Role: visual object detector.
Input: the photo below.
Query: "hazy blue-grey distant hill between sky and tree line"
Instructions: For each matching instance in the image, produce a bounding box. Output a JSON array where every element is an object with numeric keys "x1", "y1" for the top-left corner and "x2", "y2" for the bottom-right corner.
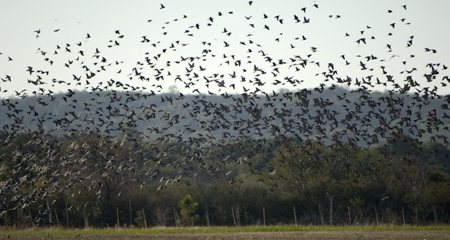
[{"x1": 0, "y1": 88, "x2": 449, "y2": 148}]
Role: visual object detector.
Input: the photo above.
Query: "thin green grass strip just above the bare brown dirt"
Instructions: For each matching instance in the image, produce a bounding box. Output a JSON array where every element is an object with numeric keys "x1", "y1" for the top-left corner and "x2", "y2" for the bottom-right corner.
[{"x1": 0, "y1": 225, "x2": 450, "y2": 235}]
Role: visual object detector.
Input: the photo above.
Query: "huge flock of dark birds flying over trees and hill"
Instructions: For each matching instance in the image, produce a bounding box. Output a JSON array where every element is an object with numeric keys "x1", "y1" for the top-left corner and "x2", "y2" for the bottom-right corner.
[{"x1": 0, "y1": 1, "x2": 450, "y2": 230}]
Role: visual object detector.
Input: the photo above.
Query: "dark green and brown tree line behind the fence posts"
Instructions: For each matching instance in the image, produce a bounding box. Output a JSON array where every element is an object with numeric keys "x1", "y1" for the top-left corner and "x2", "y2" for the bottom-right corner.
[{"x1": 0, "y1": 130, "x2": 450, "y2": 228}]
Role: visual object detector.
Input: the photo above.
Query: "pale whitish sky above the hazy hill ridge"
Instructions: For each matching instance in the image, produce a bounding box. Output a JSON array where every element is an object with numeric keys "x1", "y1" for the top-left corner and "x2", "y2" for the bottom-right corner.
[{"x1": 0, "y1": 0, "x2": 450, "y2": 98}]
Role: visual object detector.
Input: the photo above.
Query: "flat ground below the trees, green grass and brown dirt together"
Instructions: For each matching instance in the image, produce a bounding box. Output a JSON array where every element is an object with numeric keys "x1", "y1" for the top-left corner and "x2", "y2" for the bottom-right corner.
[{"x1": 0, "y1": 226, "x2": 450, "y2": 240}]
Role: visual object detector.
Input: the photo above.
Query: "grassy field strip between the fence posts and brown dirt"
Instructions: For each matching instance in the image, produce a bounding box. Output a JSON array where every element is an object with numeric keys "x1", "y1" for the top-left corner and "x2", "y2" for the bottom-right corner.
[{"x1": 0, "y1": 225, "x2": 450, "y2": 239}]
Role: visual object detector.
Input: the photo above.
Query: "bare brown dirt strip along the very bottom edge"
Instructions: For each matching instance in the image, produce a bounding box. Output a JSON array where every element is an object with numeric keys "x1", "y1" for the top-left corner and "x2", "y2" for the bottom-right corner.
[{"x1": 0, "y1": 231, "x2": 450, "y2": 240}]
